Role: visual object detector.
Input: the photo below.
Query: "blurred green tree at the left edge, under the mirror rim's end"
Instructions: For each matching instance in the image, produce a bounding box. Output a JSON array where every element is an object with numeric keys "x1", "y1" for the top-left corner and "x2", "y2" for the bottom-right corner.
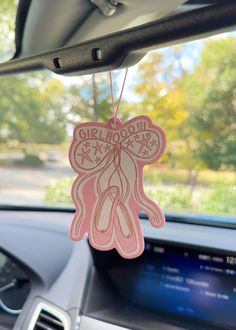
[{"x1": 0, "y1": 73, "x2": 67, "y2": 144}]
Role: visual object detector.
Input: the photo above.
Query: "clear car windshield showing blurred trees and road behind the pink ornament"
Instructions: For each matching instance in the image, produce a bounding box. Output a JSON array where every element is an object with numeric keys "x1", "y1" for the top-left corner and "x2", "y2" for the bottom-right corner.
[{"x1": 0, "y1": 1, "x2": 236, "y2": 216}]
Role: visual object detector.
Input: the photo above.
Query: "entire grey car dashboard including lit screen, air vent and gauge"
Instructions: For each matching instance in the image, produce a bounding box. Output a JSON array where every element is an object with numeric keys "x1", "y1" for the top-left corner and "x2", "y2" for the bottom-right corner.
[{"x1": 0, "y1": 210, "x2": 236, "y2": 330}]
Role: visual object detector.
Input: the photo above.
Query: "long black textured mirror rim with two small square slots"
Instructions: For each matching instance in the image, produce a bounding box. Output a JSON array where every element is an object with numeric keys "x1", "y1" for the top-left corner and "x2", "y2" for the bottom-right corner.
[{"x1": 0, "y1": 1, "x2": 236, "y2": 76}]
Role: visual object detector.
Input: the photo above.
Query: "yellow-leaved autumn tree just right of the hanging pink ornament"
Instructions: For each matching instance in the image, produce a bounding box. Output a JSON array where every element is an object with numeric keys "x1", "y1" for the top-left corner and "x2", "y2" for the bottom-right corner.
[{"x1": 135, "y1": 46, "x2": 200, "y2": 186}]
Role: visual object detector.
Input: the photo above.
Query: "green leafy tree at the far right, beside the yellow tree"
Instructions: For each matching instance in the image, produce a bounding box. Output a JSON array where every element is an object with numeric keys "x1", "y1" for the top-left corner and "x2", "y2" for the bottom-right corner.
[{"x1": 184, "y1": 37, "x2": 236, "y2": 170}]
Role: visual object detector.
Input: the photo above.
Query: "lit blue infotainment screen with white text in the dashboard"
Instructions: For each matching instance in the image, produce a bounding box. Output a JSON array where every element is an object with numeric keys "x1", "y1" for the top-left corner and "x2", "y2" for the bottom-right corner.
[{"x1": 107, "y1": 242, "x2": 236, "y2": 329}]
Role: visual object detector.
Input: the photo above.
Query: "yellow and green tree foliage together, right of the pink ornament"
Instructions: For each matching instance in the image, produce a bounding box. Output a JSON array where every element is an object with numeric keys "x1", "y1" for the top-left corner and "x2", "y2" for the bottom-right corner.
[{"x1": 135, "y1": 37, "x2": 236, "y2": 174}]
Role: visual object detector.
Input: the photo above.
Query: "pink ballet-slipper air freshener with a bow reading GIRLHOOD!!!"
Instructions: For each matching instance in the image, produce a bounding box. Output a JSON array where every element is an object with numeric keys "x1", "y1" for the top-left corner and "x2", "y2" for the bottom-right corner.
[{"x1": 69, "y1": 116, "x2": 166, "y2": 258}]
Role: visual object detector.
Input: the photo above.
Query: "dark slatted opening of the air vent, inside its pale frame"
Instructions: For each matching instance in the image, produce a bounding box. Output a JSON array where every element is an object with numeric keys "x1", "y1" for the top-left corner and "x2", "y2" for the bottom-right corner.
[{"x1": 34, "y1": 309, "x2": 65, "y2": 330}]
